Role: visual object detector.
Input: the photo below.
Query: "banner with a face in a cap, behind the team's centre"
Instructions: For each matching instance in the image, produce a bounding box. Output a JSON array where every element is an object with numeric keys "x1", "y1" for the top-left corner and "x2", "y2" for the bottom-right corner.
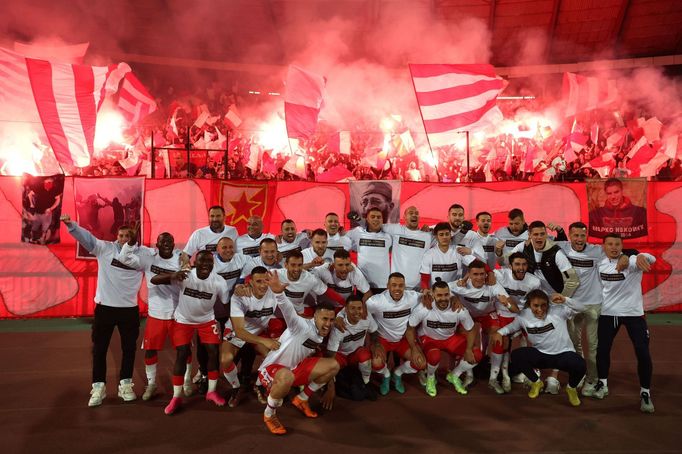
[{"x1": 350, "y1": 180, "x2": 400, "y2": 227}]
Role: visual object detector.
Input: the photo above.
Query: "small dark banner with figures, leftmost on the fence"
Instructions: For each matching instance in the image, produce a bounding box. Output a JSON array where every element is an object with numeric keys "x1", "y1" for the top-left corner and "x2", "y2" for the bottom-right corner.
[{"x1": 21, "y1": 174, "x2": 64, "y2": 244}]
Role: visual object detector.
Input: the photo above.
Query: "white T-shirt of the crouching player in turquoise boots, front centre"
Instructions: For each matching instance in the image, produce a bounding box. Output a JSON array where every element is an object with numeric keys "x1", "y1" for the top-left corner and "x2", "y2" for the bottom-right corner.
[{"x1": 365, "y1": 290, "x2": 420, "y2": 342}]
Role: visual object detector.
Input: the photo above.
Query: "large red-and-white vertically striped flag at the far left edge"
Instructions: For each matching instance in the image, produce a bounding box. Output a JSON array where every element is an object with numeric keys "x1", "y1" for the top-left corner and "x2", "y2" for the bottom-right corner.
[{"x1": 0, "y1": 48, "x2": 109, "y2": 167}]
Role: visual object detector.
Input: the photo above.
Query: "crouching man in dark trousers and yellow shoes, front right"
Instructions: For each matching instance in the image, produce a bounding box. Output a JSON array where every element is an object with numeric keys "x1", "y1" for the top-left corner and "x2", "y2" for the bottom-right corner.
[{"x1": 492, "y1": 290, "x2": 587, "y2": 407}]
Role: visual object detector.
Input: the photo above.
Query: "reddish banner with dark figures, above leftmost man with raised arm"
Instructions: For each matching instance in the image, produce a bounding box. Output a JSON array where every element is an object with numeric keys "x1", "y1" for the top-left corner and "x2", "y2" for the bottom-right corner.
[{"x1": 73, "y1": 178, "x2": 144, "y2": 258}]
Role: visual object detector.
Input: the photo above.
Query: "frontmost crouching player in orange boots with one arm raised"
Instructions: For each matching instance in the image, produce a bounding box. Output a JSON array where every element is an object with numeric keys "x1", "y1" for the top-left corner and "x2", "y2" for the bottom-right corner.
[{"x1": 258, "y1": 273, "x2": 339, "y2": 435}]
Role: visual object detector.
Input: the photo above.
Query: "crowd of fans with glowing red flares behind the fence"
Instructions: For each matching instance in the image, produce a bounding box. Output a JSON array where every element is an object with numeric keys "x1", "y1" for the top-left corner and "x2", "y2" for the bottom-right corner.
[{"x1": 6, "y1": 80, "x2": 682, "y2": 182}]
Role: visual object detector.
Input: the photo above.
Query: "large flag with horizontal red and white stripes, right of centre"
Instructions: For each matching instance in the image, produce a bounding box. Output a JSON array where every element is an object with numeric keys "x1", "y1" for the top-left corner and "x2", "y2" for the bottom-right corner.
[{"x1": 409, "y1": 64, "x2": 506, "y2": 147}]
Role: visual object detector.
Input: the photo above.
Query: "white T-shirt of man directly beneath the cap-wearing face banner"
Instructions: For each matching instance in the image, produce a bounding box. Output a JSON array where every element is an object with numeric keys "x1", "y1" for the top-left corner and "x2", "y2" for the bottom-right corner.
[{"x1": 348, "y1": 227, "x2": 393, "y2": 288}]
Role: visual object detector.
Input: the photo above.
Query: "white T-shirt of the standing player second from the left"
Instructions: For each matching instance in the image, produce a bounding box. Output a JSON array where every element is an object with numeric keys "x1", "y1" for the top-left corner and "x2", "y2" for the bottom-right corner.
[{"x1": 118, "y1": 243, "x2": 180, "y2": 320}]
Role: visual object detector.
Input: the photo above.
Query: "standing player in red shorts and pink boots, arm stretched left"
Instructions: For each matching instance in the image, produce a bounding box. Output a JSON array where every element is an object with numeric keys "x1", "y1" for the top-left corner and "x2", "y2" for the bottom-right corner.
[{"x1": 151, "y1": 250, "x2": 230, "y2": 415}]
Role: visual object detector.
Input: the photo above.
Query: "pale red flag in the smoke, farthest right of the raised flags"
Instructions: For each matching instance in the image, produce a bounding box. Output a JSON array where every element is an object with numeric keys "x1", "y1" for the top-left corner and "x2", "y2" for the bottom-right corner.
[{"x1": 563, "y1": 73, "x2": 618, "y2": 117}]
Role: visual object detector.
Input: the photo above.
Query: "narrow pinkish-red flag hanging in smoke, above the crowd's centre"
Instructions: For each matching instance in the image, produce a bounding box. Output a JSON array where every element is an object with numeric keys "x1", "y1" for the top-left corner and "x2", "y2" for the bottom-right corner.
[{"x1": 284, "y1": 65, "x2": 326, "y2": 139}]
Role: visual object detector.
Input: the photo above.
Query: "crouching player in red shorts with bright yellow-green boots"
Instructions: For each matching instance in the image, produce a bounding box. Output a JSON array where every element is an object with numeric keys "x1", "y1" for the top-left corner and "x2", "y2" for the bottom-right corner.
[{"x1": 405, "y1": 281, "x2": 483, "y2": 397}]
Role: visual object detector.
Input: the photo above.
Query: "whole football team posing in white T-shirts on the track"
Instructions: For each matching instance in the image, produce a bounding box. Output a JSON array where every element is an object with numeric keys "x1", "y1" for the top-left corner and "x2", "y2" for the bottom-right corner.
[{"x1": 61, "y1": 180, "x2": 655, "y2": 435}]
